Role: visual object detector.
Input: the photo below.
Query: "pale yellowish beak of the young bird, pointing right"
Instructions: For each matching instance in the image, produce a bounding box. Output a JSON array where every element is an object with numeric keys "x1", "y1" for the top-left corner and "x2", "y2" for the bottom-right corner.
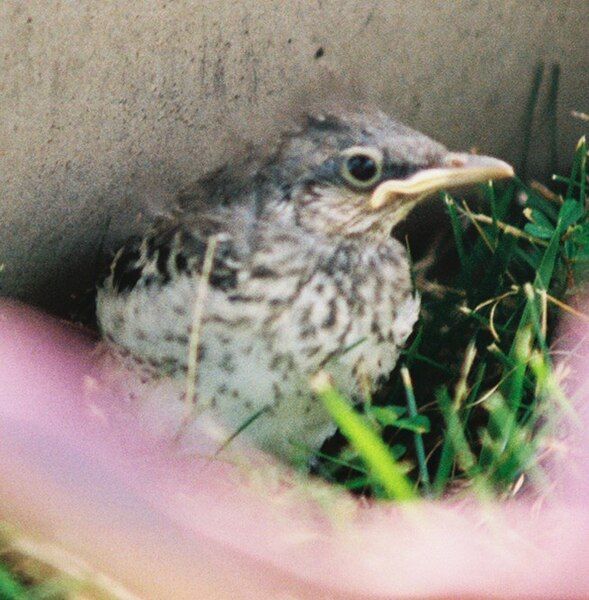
[{"x1": 370, "y1": 152, "x2": 514, "y2": 210}]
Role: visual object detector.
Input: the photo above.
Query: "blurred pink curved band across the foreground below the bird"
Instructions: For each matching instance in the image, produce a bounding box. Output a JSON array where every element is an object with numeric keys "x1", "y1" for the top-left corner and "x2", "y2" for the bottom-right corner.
[{"x1": 0, "y1": 303, "x2": 589, "y2": 598}]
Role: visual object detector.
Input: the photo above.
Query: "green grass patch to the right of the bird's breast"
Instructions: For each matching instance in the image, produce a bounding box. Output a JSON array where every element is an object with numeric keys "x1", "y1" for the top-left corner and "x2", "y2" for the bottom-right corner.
[{"x1": 316, "y1": 139, "x2": 589, "y2": 500}]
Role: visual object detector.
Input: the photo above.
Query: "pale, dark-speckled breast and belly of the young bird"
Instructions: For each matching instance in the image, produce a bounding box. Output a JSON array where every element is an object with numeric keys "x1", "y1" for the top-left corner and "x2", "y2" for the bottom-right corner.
[{"x1": 98, "y1": 234, "x2": 419, "y2": 457}]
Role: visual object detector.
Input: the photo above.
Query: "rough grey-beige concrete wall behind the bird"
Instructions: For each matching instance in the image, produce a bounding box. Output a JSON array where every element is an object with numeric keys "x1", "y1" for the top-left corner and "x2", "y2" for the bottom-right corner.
[{"x1": 0, "y1": 0, "x2": 589, "y2": 307}]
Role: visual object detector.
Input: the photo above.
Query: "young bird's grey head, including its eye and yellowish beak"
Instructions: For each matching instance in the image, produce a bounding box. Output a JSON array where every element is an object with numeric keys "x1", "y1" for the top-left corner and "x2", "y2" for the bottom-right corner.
[{"x1": 264, "y1": 112, "x2": 513, "y2": 238}]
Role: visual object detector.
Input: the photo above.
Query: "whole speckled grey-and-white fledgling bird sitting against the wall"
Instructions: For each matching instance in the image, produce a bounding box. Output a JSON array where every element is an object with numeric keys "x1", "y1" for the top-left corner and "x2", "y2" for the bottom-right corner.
[{"x1": 96, "y1": 110, "x2": 513, "y2": 463}]
